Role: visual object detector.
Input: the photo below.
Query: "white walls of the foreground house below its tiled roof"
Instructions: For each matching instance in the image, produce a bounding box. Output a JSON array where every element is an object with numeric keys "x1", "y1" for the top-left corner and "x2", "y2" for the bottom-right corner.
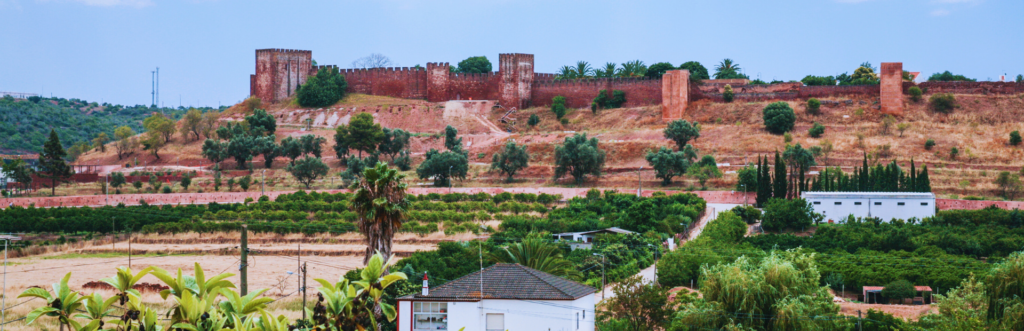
[{"x1": 398, "y1": 294, "x2": 595, "y2": 331}]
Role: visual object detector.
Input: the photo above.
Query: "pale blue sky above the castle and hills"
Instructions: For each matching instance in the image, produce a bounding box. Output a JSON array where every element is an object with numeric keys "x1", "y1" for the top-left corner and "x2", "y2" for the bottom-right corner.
[{"x1": 0, "y1": 0, "x2": 1024, "y2": 107}]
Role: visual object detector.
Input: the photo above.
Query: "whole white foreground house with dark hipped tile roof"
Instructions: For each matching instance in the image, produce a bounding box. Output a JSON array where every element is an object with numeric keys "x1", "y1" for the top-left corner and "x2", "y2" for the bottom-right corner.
[{"x1": 397, "y1": 263, "x2": 596, "y2": 331}]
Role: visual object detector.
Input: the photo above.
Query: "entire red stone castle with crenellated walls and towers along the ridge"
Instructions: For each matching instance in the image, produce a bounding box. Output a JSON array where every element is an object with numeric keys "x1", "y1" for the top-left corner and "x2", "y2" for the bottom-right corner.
[{"x1": 249, "y1": 48, "x2": 1024, "y2": 122}]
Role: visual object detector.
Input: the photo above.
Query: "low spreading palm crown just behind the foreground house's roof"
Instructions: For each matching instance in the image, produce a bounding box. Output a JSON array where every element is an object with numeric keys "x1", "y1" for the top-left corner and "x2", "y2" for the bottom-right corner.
[{"x1": 487, "y1": 239, "x2": 581, "y2": 279}]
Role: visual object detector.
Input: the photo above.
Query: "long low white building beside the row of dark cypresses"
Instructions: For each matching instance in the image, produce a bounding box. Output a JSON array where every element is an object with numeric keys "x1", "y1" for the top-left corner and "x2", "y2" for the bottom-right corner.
[{"x1": 801, "y1": 192, "x2": 935, "y2": 221}]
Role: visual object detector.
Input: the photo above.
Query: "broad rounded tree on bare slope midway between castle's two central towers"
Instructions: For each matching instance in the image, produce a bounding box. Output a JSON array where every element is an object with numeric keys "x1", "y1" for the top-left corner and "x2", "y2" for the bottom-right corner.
[{"x1": 555, "y1": 133, "x2": 604, "y2": 184}]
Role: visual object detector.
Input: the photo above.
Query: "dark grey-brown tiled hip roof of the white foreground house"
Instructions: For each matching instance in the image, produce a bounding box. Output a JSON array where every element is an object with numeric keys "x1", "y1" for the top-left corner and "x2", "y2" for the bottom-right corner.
[{"x1": 402, "y1": 263, "x2": 597, "y2": 300}]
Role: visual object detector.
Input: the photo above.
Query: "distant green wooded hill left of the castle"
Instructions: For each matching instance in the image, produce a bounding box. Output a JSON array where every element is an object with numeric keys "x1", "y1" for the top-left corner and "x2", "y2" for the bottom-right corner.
[{"x1": 0, "y1": 96, "x2": 222, "y2": 153}]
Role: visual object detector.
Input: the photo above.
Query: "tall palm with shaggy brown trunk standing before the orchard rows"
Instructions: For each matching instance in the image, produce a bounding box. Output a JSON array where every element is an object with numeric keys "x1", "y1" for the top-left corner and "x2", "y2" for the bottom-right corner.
[{"x1": 352, "y1": 162, "x2": 409, "y2": 263}]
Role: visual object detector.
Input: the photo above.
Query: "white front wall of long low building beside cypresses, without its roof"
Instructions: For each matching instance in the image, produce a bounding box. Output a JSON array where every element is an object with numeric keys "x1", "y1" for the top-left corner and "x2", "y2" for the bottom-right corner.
[{"x1": 807, "y1": 198, "x2": 935, "y2": 222}]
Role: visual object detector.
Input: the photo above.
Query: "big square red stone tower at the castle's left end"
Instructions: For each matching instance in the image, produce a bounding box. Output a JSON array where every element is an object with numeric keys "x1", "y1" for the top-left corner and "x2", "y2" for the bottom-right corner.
[{"x1": 249, "y1": 48, "x2": 312, "y2": 104}]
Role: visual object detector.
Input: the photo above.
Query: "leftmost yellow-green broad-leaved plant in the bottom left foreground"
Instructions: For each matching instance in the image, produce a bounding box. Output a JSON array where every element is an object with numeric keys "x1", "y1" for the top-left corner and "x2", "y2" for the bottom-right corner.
[{"x1": 17, "y1": 273, "x2": 86, "y2": 331}]
